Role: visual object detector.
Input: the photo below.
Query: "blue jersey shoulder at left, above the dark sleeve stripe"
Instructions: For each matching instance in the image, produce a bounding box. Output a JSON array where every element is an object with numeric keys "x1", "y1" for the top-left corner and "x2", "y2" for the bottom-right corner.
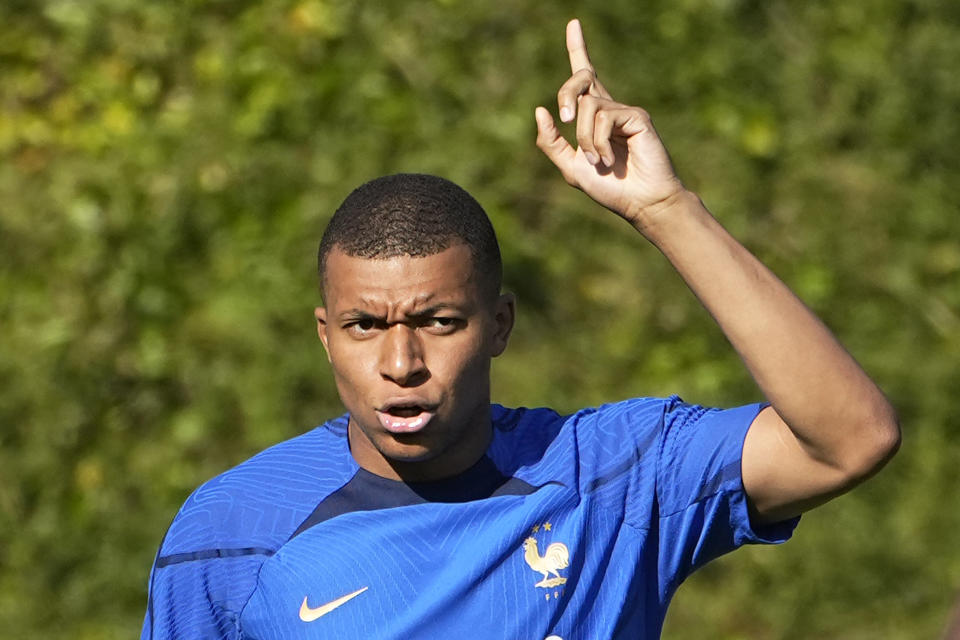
[{"x1": 161, "y1": 417, "x2": 354, "y2": 555}]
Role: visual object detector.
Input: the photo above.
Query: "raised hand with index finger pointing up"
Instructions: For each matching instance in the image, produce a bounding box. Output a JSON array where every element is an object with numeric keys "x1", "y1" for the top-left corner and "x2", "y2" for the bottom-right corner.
[{"x1": 536, "y1": 20, "x2": 684, "y2": 230}]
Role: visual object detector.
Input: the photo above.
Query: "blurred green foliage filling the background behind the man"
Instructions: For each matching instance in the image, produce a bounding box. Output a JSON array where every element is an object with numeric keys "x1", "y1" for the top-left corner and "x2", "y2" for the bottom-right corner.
[{"x1": 0, "y1": 0, "x2": 960, "y2": 640}]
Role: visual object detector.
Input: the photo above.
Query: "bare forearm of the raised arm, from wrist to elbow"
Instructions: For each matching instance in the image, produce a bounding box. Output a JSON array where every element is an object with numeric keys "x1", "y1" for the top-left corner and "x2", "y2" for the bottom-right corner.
[{"x1": 635, "y1": 192, "x2": 898, "y2": 473}]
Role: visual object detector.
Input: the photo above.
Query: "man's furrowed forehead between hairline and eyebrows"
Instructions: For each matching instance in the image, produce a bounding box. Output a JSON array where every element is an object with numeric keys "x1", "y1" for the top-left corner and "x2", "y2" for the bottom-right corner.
[{"x1": 324, "y1": 245, "x2": 479, "y2": 307}]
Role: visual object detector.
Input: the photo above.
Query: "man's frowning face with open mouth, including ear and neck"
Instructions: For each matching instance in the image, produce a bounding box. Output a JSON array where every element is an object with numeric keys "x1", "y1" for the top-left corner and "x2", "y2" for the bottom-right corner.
[{"x1": 316, "y1": 244, "x2": 514, "y2": 480}]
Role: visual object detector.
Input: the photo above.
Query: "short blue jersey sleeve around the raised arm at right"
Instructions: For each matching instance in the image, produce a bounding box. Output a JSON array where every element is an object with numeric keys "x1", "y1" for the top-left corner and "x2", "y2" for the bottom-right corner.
[{"x1": 656, "y1": 398, "x2": 799, "y2": 586}]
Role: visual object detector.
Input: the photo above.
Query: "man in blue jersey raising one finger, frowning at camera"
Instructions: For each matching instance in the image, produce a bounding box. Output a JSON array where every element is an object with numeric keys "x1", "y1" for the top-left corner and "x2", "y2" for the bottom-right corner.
[{"x1": 143, "y1": 21, "x2": 899, "y2": 640}]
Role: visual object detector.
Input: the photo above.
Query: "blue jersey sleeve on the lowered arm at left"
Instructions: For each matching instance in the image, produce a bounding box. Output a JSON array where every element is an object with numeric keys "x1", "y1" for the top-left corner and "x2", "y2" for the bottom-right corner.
[{"x1": 141, "y1": 417, "x2": 353, "y2": 640}]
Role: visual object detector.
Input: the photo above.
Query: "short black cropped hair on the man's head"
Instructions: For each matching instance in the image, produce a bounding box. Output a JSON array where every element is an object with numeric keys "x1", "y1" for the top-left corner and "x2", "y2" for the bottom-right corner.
[{"x1": 317, "y1": 173, "x2": 503, "y2": 296}]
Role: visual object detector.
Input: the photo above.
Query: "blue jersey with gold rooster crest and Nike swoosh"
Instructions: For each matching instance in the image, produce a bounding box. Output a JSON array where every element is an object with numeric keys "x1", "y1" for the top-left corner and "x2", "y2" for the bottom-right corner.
[{"x1": 142, "y1": 397, "x2": 796, "y2": 640}]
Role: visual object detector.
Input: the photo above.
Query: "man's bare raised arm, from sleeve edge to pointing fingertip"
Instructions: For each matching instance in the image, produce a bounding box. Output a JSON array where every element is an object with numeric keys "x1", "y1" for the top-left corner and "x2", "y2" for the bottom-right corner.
[{"x1": 536, "y1": 20, "x2": 900, "y2": 522}]
